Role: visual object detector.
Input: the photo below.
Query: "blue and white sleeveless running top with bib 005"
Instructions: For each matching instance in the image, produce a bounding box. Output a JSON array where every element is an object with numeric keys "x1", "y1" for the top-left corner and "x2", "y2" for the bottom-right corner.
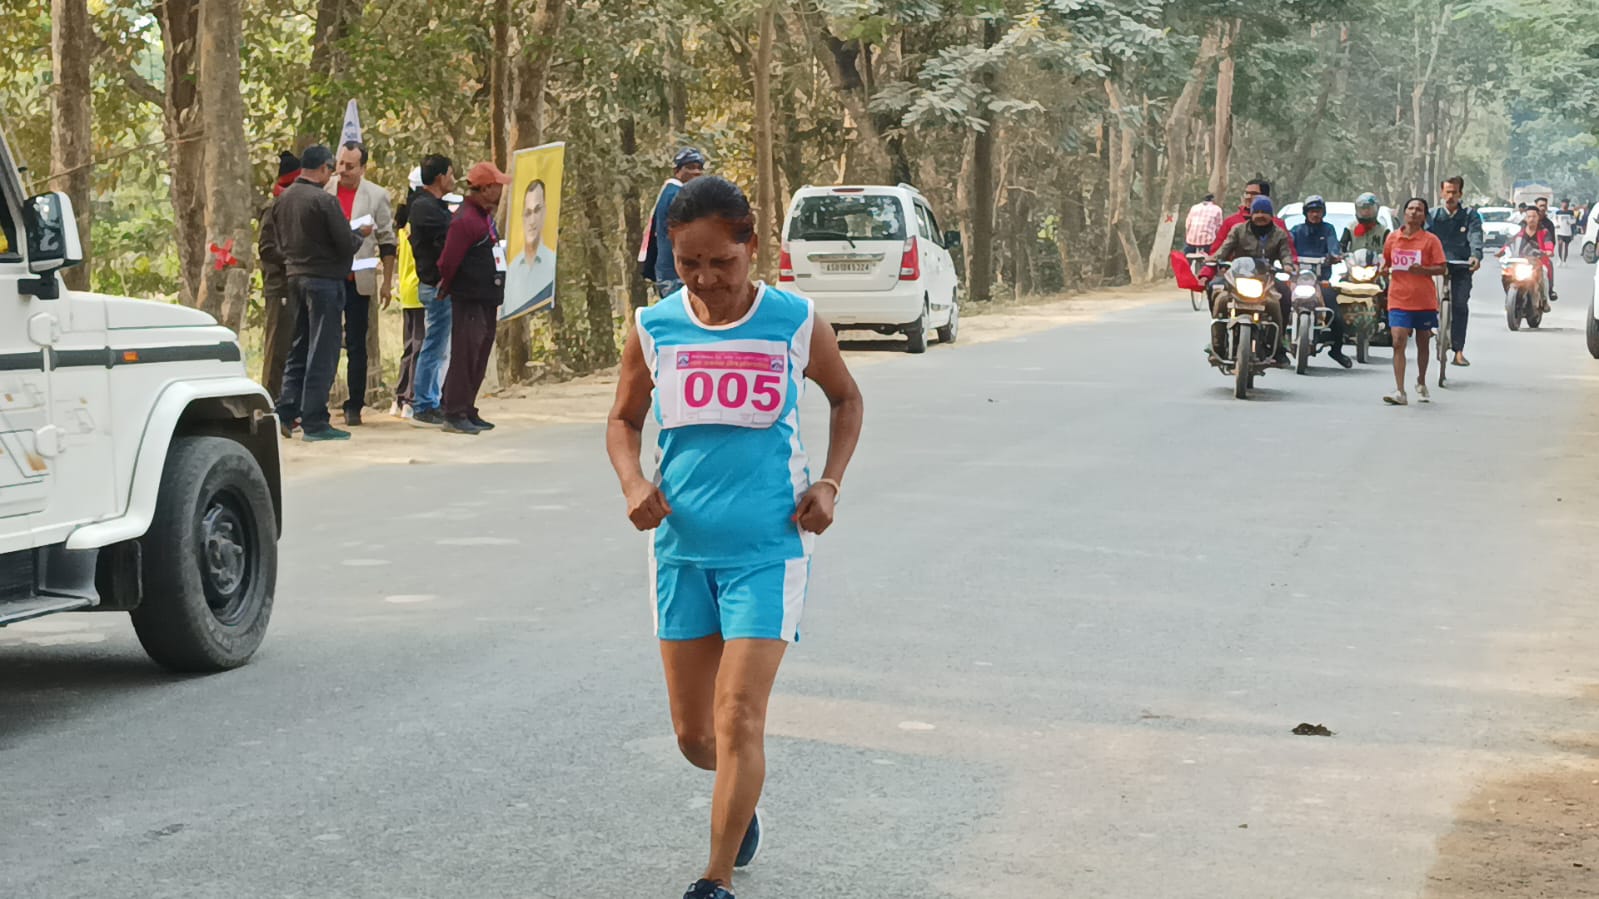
[{"x1": 638, "y1": 285, "x2": 815, "y2": 568}]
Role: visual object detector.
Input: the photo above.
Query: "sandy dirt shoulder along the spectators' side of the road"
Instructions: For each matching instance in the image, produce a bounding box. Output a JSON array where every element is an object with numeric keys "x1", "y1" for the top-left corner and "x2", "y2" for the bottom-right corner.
[{"x1": 281, "y1": 282, "x2": 1176, "y2": 478}]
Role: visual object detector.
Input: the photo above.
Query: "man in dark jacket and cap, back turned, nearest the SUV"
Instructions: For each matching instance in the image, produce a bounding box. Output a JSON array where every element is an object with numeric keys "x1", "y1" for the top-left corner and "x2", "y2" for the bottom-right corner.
[{"x1": 273, "y1": 146, "x2": 373, "y2": 442}]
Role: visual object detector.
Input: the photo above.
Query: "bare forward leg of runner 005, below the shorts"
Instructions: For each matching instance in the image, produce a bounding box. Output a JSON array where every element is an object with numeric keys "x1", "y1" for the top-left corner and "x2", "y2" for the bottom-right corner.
[{"x1": 704, "y1": 638, "x2": 788, "y2": 888}]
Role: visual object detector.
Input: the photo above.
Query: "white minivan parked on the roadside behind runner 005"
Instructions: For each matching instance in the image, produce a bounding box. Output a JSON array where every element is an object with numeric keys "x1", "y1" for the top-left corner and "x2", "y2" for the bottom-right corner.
[{"x1": 779, "y1": 184, "x2": 961, "y2": 354}]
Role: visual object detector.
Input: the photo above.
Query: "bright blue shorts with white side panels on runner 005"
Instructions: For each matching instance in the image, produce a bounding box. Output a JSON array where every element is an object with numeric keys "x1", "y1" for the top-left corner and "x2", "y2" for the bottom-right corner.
[{"x1": 649, "y1": 553, "x2": 811, "y2": 643}]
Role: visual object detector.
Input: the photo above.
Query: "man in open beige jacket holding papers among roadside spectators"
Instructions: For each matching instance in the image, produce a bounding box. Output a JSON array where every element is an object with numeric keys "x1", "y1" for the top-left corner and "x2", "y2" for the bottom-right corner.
[{"x1": 328, "y1": 141, "x2": 400, "y2": 427}]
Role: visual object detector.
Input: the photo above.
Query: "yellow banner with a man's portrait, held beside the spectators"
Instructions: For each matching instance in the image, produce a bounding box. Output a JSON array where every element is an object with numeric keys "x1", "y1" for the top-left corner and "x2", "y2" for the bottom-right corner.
[{"x1": 500, "y1": 142, "x2": 566, "y2": 322}]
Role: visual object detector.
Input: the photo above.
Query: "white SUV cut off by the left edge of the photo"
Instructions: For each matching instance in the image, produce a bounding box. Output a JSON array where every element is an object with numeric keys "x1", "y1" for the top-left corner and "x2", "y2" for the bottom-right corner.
[{"x1": 0, "y1": 127, "x2": 283, "y2": 672}]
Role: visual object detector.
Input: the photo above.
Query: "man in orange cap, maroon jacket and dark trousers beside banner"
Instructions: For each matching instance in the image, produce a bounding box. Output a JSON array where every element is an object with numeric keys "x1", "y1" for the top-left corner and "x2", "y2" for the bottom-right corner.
[{"x1": 438, "y1": 162, "x2": 510, "y2": 437}]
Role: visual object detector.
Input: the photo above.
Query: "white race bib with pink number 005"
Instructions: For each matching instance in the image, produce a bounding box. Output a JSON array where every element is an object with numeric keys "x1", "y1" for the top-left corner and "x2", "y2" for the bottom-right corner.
[{"x1": 656, "y1": 341, "x2": 788, "y2": 429}]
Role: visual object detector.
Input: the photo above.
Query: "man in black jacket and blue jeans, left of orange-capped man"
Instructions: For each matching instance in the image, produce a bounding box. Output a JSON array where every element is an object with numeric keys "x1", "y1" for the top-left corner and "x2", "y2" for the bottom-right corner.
[{"x1": 406, "y1": 154, "x2": 459, "y2": 427}]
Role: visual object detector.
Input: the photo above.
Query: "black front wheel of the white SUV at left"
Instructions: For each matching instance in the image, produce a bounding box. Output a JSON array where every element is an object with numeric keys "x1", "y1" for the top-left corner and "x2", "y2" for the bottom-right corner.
[{"x1": 133, "y1": 437, "x2": 278, "y2": 672}]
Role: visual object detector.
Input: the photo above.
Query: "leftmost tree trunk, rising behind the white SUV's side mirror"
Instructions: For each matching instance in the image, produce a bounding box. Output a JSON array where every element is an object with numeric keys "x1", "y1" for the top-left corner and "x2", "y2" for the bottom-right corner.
[{"x1": 50, "y1": 0, "x2": 94, "y2": 290}]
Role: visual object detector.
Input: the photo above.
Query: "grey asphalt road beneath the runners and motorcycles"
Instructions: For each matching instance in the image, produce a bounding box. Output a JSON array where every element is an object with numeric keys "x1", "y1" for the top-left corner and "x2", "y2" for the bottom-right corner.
[{"x1": 0, "y1": 264, "x2": 1599, "y2": 899}]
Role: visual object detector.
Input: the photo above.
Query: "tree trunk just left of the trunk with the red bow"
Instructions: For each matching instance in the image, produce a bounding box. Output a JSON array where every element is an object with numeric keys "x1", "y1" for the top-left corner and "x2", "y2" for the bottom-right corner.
[{"x1": 155, "y1": 0, "x2": 206, "y2": 306}]
